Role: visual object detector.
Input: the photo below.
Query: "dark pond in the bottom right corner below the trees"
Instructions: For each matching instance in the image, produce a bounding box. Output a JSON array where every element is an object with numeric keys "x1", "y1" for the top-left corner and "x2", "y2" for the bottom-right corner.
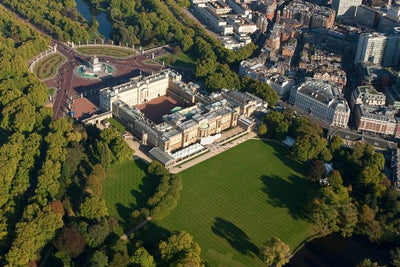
[{"x1": 285, "y1": 234, "x2": 394, "y2": 267}]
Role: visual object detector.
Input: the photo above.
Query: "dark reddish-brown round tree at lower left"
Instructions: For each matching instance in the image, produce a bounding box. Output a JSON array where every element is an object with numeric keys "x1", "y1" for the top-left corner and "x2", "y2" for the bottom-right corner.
[{"x1": 54, "y1": 227, "x2": 86, "y2": 257}]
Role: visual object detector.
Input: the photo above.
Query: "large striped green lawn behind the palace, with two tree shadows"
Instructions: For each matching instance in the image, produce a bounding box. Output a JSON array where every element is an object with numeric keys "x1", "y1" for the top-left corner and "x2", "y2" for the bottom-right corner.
[{"x1": 157, "y1": 140, "x2": 311, "y2": 266}]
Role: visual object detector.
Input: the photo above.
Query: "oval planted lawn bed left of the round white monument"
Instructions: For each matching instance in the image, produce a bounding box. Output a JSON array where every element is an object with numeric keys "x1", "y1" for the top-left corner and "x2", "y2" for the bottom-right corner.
[{"x1": 33, "y1": 53, "x2": 65, "y2": 80}]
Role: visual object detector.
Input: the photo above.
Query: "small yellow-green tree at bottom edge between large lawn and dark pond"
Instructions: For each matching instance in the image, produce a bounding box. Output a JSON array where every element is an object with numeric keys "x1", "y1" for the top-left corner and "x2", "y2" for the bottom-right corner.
[{"x1": 260, "y1": 237, "x2": 290, "y2": 267}]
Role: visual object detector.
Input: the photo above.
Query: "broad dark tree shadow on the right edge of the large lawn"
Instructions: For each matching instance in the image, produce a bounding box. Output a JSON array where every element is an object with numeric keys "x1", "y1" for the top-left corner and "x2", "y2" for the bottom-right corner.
[{"x1": 261, "y1": 175, "x2": 315, "y2": 221}]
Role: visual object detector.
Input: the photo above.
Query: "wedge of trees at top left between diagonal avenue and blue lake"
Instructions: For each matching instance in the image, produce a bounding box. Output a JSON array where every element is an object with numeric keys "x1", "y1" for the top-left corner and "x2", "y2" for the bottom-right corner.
[{"x1": 2, "y1": 0, "x2": 89, "y2": 42}]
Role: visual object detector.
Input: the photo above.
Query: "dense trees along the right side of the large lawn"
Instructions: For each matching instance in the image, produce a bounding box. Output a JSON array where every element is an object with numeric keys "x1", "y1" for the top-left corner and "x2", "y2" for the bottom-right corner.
[{"x1": 264, "y1": 110, "x2": 400, "y2": 266}]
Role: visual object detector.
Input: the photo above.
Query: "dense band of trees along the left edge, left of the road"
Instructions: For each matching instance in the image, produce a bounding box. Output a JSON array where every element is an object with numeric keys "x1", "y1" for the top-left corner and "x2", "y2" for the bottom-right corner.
[{"x1": 0, "y1": 6, "x2": 52, "y2": 261}]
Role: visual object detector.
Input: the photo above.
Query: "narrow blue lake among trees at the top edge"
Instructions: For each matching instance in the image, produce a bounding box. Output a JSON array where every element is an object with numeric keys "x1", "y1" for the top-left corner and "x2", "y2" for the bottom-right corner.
[{"x1": 75, "y1": 0, "x2": 112, "y2": 40}]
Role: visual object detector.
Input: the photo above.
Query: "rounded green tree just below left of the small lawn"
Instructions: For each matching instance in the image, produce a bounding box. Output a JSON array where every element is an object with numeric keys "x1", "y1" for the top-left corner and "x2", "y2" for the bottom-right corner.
[{"x1": 78, "y1": 195, "x2": 108, "y2": 220}]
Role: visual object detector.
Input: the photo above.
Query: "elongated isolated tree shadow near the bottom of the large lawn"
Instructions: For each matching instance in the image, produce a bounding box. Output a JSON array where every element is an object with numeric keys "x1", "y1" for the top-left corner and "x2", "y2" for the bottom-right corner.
[{"x1": 211, "y1": 217, "x2": 259, "y2": 258}]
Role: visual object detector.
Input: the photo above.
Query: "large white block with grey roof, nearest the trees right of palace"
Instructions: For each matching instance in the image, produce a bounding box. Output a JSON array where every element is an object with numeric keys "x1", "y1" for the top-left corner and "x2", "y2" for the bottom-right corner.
[{"x1": 289, "y1": 79, "x2": 350, "y2": 127}]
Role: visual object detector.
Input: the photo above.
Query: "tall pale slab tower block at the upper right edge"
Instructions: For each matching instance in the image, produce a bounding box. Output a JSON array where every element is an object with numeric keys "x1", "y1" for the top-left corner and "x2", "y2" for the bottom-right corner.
[{"x1": 354, "y1": 28, "x2": 400, "y2": 66}]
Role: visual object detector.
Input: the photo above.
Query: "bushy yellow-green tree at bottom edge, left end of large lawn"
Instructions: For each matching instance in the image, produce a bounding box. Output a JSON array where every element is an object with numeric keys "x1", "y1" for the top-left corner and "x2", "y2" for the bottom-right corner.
[{"x1": 159, "y1": 231, "x2": 203, "y2": 266}]
